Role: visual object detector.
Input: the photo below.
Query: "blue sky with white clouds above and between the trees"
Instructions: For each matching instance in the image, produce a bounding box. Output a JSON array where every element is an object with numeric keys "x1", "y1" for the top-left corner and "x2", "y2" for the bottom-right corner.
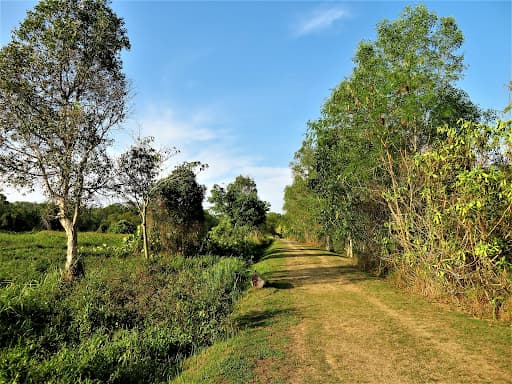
[{"x1": 0, "y1": 0, "x2": 512, "y2": 211}]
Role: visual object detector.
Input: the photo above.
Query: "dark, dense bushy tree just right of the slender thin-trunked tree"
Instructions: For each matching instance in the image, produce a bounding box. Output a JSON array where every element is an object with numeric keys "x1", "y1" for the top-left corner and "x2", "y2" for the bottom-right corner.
[{"x1": 152, "y1": 162, "x2": 206, "y2": 254}]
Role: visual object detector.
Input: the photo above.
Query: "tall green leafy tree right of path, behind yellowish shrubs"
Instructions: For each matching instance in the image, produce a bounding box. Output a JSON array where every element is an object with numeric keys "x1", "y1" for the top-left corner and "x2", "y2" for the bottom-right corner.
[{"x1": 282, "y1": 6, "x2": 480, "y2": 268}]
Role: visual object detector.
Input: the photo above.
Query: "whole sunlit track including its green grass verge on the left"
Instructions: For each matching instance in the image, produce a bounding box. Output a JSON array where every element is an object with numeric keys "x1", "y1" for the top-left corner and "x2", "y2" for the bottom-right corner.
[{"x1": 176, "y1": 241, "x2": 512, "y2": 383}]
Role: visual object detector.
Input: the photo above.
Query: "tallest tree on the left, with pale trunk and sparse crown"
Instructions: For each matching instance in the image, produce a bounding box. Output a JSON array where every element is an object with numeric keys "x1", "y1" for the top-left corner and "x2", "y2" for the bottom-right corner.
[{"x1": 0, "y1": 0, "x2": 130, "y2": 279}]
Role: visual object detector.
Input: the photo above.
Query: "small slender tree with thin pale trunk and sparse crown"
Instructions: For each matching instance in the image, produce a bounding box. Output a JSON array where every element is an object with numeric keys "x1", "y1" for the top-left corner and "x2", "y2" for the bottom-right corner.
[{"x1": 116, "y1": 137, "x2": 175, "y2": 259}]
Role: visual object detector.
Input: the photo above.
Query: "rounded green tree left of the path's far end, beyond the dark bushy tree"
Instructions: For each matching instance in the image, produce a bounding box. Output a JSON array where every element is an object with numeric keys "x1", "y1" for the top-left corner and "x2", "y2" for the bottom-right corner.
[{"x1": 208, "y1": 175, "x2": 270, "y2": 227}]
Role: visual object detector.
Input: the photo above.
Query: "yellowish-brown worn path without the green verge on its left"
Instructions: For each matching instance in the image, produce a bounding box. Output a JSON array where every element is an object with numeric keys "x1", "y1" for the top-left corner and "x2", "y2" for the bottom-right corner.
[{"x1": 264, "y1": 241, "x2": 512, "y2": 383}]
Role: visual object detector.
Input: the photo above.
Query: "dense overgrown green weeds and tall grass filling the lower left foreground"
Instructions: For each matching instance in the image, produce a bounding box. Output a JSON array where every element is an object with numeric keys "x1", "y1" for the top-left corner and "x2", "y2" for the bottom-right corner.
[{"x1": 0, "y1": 250, "x2": 246, "y2": 383}]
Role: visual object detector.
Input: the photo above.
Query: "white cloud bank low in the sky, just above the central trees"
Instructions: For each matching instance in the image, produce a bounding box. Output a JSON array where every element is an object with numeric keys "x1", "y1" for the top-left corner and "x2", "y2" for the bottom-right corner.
[{"x1": 3, "y1": 105, "x2": 292, "y2": 212}]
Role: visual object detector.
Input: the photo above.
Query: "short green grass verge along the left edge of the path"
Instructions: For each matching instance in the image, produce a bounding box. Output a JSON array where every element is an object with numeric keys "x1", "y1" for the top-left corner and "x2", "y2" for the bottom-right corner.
[{"x1": 170, "y1": 242, "x2": 298, "y2": 384}]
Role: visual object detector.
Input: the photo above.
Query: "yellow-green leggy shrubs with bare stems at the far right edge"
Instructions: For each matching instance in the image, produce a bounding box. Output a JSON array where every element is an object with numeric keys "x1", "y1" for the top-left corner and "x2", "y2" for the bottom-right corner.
[{"x1": 386, "y1": 121, "x2": 512, "y2": 316}]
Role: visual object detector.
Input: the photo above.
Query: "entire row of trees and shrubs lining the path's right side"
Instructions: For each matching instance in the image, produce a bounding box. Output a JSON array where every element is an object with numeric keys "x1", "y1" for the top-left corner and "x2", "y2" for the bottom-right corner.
[{"x1": 284, "y1": 5, "x2": 512, "y2": 316}]
